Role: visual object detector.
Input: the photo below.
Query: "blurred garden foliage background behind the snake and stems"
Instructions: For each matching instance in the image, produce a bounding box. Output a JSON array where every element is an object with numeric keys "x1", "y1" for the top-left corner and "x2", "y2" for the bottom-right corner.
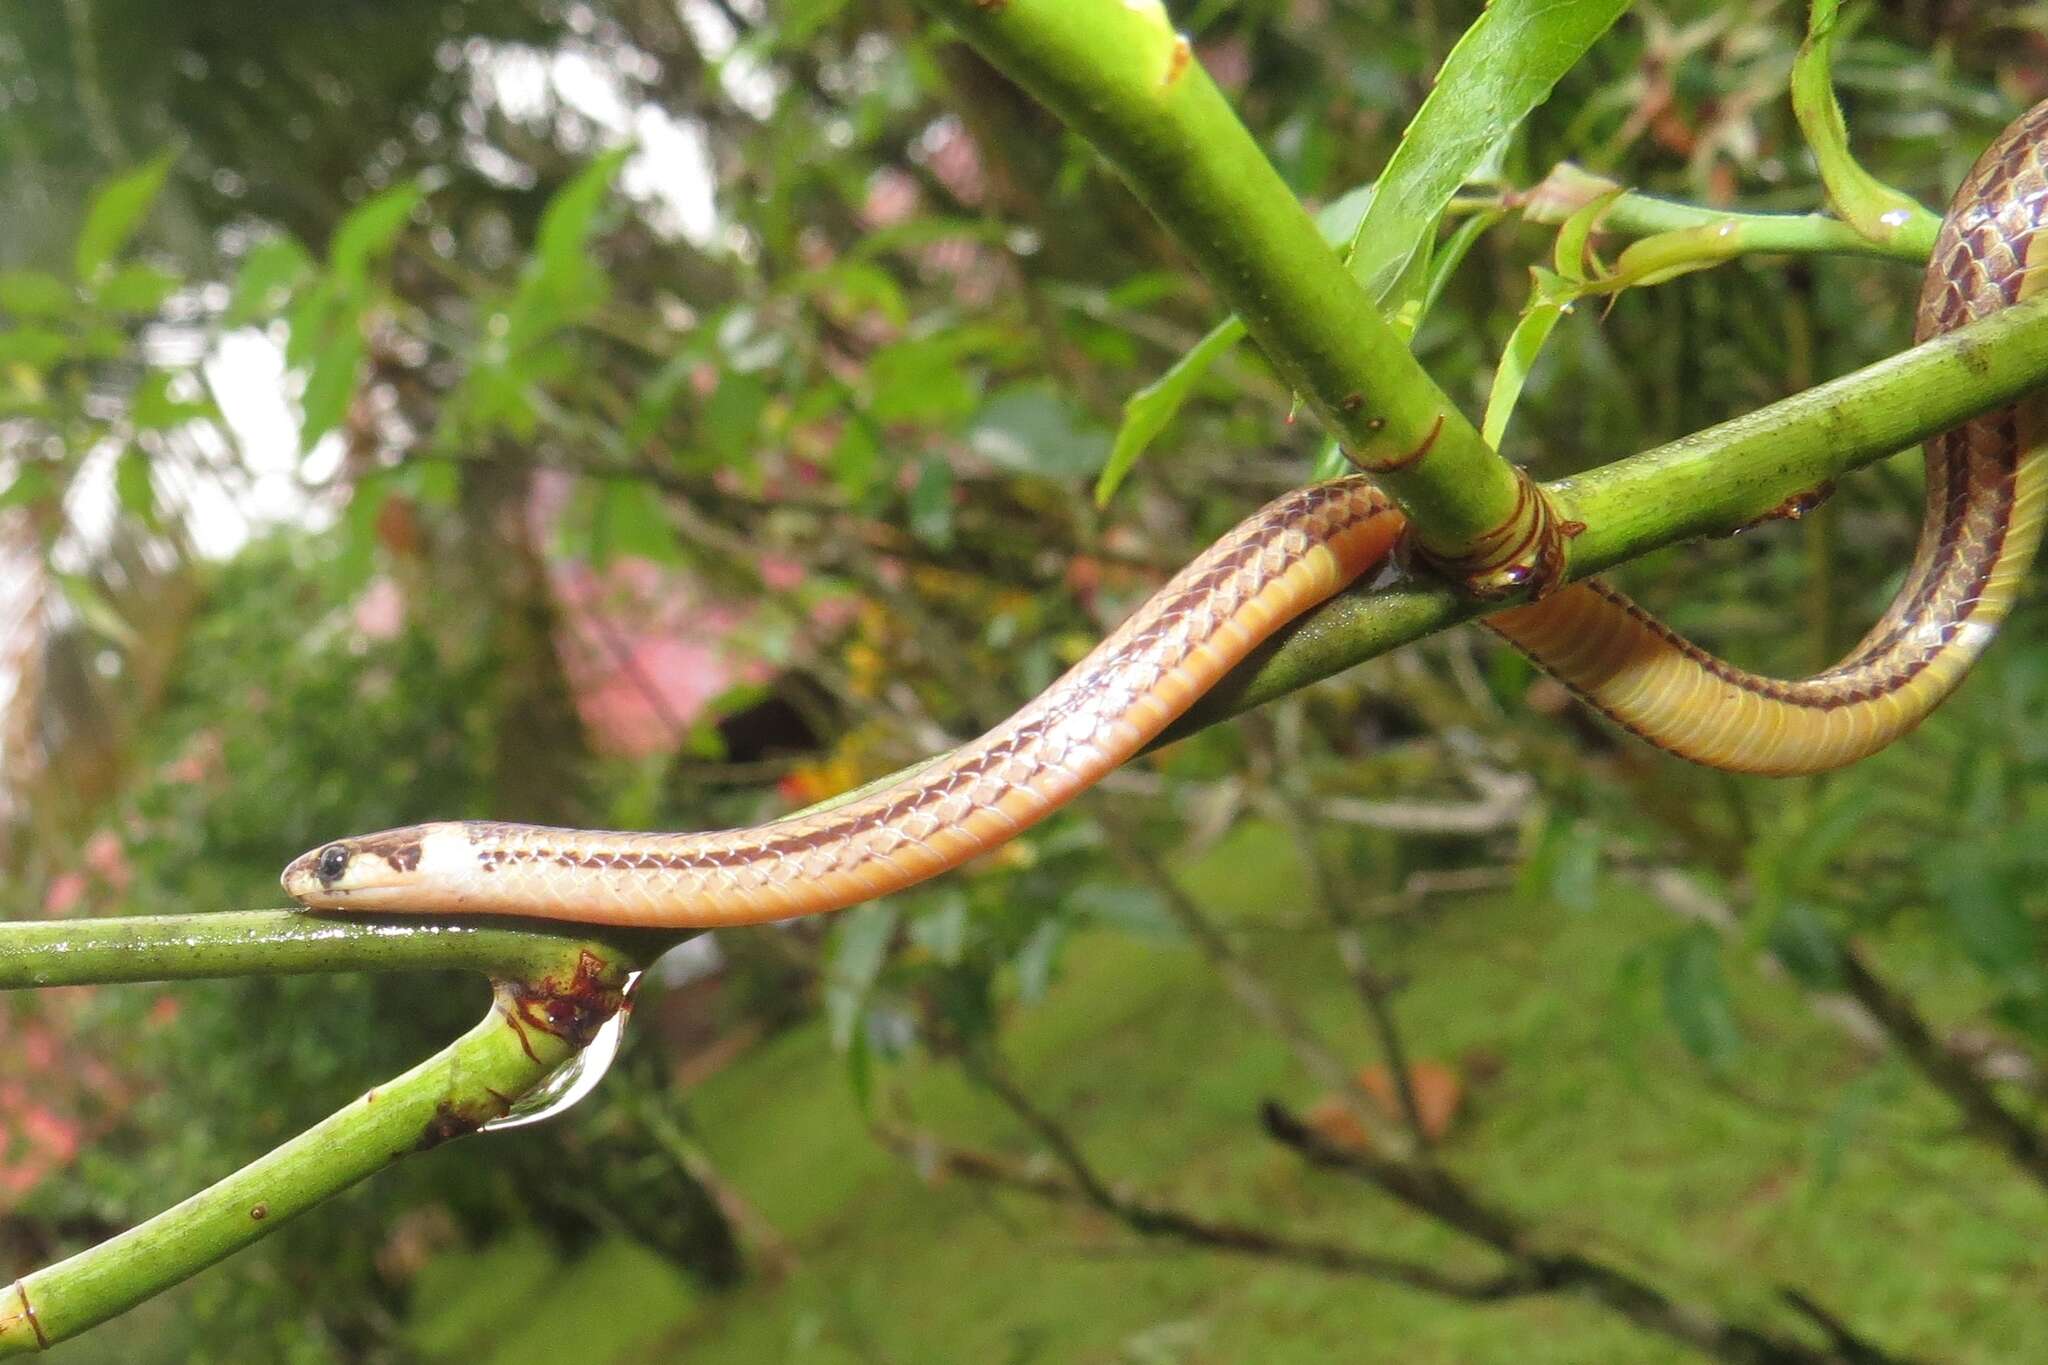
[{"x1": 12, "y1": 0, "x2": 2048, "y2": 1361}]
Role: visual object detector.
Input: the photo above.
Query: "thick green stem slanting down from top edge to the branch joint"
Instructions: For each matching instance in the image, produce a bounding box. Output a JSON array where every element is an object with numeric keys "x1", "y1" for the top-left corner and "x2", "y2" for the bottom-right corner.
[{"x1": 920, "y1": 0, "x2": 1518, "y2": 557}]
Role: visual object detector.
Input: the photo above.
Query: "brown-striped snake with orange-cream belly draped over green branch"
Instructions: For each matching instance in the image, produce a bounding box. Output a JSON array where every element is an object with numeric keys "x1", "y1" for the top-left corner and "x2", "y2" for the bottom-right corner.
[{"x1": 283, "y1": 100, "x2": 2048, "y2": 929}]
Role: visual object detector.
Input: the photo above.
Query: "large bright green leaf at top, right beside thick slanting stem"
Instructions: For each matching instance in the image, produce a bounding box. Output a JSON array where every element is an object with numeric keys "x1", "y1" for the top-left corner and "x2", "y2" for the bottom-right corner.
[{"x1": 1350, "y1": 0, "x2": 1628, "y2": 313}]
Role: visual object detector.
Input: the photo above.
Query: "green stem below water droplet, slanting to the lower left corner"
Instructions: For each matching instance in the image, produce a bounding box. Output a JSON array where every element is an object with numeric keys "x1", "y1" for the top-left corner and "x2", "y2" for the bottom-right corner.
[{"x1": 0, "y1": 990, "x2": 575, "y2": 1355}]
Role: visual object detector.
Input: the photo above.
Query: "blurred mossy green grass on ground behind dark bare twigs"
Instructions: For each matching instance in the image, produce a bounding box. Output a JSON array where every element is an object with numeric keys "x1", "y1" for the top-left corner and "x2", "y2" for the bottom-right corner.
[{"x1": 387, "y1": 825, "x2": 2048, "y2": 1365}]
